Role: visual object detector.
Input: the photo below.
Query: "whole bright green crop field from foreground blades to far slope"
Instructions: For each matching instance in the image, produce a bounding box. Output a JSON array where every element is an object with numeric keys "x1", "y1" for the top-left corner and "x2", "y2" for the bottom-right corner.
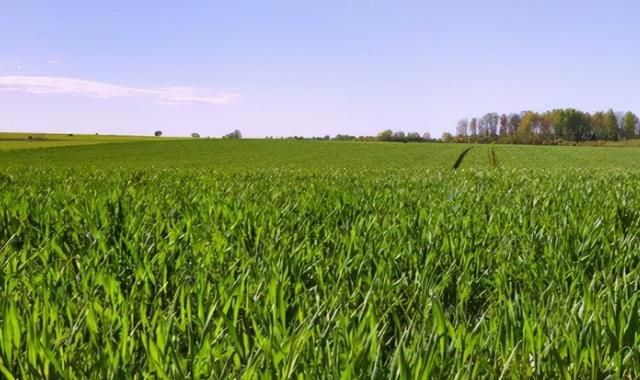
[{"x1": 0, "y1": 139, "x2": 640, "y2": 379}]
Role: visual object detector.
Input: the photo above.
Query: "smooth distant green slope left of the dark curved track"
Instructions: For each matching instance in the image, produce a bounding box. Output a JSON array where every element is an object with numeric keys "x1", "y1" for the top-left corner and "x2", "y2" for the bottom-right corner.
[{"x1": 0, "y1": 139, "x2": 466, "y2": 170}]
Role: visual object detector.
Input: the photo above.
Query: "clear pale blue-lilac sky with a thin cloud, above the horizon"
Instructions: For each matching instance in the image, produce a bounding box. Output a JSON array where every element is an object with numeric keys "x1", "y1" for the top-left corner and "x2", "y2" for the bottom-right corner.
[{"x1": 0, "y1": 0, "x2": 640, "y2": 137}]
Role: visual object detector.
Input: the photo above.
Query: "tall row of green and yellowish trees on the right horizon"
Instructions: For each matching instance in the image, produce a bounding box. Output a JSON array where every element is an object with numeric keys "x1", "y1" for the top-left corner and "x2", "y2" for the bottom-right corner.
[{"x1": 452, "y1": 108, "x2": 640, "y2": 144}]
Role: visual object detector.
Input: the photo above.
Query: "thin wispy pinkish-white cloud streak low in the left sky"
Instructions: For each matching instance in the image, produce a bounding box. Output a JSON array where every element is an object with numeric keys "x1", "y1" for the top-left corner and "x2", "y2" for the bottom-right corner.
[{"x1": 0, "y1": 75, "x2": 240, "y2": 104}]
